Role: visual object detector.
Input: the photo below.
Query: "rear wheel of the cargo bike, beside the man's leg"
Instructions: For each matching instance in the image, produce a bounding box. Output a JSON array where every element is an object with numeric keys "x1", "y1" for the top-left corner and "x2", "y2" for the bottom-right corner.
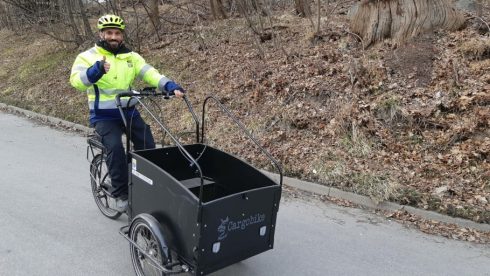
[{"x1": 90, "y1": 154, "x2": 122, "y2": 219}]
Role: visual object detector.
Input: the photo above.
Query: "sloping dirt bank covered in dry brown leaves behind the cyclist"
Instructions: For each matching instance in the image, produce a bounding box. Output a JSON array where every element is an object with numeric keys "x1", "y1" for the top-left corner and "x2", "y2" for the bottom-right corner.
[{"x1": 0, "y1": 2, "x2": 490, "y2": 229}]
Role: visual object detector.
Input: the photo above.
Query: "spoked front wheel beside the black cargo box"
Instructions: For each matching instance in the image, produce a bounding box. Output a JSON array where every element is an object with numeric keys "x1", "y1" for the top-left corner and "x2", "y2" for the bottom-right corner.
[{"x1": 129, "y1": 218, "x2": 167, "y2": 276}]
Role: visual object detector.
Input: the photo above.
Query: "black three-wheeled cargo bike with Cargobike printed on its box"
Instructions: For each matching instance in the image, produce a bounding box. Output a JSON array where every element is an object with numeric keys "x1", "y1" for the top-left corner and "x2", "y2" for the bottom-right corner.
[{"x1": 87, "y1": 90, "x2": 283, "y2": 276}]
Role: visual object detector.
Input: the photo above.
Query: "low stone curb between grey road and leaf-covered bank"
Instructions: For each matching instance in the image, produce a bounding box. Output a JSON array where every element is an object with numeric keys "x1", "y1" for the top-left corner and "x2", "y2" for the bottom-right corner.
[{"x1": 0, "y1": 103, "x2": 490, "y2": 232}]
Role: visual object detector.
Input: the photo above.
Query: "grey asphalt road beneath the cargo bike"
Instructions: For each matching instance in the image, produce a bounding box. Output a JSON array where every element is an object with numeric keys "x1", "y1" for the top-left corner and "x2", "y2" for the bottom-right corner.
[{"x1": 0, "y1": 112, "x2": 490, "y2": 276}]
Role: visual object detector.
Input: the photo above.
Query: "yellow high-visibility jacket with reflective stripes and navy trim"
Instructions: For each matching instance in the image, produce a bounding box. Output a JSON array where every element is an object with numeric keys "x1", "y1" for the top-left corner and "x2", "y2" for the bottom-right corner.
[{"x1": 70, "y1": 45, "x2": 170, "y2": 124}]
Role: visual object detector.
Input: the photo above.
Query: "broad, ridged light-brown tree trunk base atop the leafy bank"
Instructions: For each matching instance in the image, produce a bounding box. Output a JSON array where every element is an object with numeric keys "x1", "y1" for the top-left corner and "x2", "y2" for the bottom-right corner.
[{"x1": 350, "y1": 0, "x2": 465, "y2": 47}]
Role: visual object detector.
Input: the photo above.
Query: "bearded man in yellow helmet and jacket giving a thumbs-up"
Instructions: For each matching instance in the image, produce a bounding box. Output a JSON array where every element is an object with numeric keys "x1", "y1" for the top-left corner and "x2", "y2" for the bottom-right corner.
[{"x1": 70, "y1": 15, "x2": 184, "y2": 212}]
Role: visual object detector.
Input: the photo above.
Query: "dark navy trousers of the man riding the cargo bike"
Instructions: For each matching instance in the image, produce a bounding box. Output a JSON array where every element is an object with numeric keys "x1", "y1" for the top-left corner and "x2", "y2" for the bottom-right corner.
[{"x1": 95, "y1": 116, "x2": 155, "y2": 197}]
